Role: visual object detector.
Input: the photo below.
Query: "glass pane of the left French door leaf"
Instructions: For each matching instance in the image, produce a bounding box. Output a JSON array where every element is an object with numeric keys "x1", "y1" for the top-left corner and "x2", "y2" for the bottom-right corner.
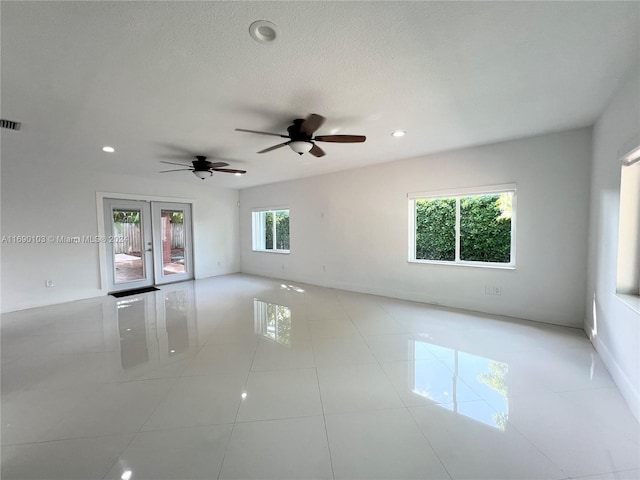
[{"x1": 113, "y1": 209, "x2": 145, "y2": 283}]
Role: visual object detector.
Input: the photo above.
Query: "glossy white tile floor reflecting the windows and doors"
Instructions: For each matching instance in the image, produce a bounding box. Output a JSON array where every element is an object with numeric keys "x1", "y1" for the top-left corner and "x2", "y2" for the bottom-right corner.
[{"x1": 2, "y1": 275, "x2": 640, "y2": 480}]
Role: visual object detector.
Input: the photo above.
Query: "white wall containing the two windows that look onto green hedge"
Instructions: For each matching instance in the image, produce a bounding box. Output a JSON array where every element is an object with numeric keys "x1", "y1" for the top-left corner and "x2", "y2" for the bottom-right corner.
[{"x1": 240, "y1": 128, "x2": 591, "y2": 327}]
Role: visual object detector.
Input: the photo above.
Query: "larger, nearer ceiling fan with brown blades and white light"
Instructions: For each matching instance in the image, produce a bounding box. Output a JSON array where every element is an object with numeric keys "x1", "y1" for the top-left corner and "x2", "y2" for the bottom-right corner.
[{"x1": 236, "y1": 113, "x2": 367, "y2": 157}]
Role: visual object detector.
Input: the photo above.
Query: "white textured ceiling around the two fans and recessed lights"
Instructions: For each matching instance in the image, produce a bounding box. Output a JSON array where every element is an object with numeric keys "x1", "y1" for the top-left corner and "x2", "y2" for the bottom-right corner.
[{"x1": 0, "y1": 1, "x2": 640, "y2": 188}]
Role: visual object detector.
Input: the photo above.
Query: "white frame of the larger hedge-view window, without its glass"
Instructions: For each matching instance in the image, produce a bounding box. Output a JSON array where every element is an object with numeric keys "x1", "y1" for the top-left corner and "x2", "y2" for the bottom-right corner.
[{"x1": 407, "y1": 183, "x2": 518, "y2": 270}]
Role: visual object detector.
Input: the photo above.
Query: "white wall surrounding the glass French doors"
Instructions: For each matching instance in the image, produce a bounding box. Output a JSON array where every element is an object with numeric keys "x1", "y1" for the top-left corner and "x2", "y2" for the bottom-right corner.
[{"x1": 1, "y1": 163, "x2": 239, "y2": 312}]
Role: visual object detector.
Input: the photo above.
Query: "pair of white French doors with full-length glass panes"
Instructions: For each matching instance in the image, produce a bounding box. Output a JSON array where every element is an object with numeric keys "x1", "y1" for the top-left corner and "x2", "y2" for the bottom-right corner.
[{"x1": 104, "y1": 198, "x2": 193, "y2": 292}]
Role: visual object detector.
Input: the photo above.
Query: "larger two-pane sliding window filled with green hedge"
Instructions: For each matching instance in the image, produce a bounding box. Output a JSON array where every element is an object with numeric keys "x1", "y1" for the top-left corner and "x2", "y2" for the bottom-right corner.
[{"x1": 408, "y1": 184, "x2": 516, "y2": 268}]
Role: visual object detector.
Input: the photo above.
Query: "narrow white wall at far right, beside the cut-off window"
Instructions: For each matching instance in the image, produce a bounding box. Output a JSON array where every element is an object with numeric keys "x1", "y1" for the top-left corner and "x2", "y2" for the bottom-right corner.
[{"x1": 585, "y1": 67, "x2": 640, "y2": 418}]
